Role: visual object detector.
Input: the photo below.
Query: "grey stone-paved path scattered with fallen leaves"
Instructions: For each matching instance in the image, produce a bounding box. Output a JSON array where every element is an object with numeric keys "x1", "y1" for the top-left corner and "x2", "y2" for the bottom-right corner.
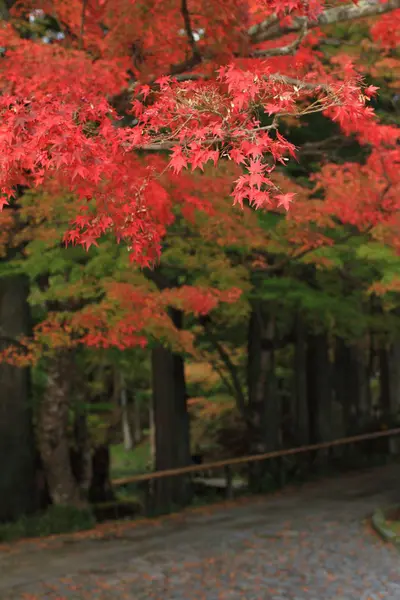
[{"x1": 0, "y1": 466, "x2": 400, "y2": 600}]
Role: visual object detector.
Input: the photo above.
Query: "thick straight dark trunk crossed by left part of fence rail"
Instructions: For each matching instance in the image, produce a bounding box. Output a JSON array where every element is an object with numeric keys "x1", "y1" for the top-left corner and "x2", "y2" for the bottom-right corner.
[{"x1": 152, "y1": 310, "x2": 191, "y2": 511}]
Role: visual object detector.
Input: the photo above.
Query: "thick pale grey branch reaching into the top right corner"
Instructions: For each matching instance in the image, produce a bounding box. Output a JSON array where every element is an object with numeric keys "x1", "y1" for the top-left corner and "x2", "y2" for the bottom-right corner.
[{"x1": 248, "y1": 0, "x2": 400, "y2": 44}]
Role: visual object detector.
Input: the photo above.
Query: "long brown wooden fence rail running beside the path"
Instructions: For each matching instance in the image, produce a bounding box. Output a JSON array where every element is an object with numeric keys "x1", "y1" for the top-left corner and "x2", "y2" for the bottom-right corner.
[{"x1": 111, "y1": 427, "x2": 400, "y2": 487}]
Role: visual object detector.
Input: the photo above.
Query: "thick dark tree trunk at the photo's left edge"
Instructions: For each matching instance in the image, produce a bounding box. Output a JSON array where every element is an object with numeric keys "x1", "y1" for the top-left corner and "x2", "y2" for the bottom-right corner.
[{"x1": 0, "y1": 276, "x2": 39, "y2": 521}]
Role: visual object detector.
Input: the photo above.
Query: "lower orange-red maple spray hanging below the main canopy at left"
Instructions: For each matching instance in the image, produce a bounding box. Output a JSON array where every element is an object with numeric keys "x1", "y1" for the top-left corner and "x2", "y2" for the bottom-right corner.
[{"x1": 0, "y1": 282, "x2": 242, "y2": 366}]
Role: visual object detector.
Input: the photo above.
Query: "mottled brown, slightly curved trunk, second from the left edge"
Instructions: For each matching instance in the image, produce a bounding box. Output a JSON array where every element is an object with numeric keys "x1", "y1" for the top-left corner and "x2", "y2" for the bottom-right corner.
[{"x1": 38, "y1": 350, "x2": 85, "y2": 507}]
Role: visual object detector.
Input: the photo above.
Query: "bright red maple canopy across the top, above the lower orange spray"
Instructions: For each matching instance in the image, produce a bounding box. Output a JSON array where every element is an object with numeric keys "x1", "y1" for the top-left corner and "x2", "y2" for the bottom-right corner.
[{"x1": 0, "y1": 0, "x2": 400, "y2": 265}]
